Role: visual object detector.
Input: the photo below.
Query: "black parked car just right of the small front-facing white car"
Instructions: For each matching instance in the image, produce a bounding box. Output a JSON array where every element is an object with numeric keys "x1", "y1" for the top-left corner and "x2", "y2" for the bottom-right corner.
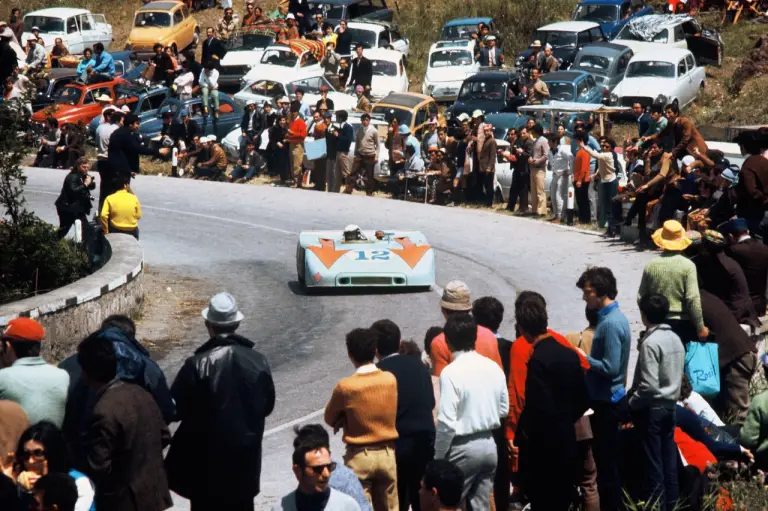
[{"x1": 445, "y1": 69, "x2": 525, "y2": 122}]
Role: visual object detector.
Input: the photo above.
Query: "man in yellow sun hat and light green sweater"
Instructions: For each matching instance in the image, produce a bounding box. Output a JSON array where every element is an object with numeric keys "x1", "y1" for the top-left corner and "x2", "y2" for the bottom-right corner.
[{"x1": 637, "y1": 220, "x2": 709, "y2": 344}]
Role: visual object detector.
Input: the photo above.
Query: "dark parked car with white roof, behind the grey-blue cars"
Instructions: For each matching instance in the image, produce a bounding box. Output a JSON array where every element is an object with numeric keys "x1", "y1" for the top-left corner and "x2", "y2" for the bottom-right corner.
[{"x1": 515, "y1": 21, "x2": 608, "y2": 69}]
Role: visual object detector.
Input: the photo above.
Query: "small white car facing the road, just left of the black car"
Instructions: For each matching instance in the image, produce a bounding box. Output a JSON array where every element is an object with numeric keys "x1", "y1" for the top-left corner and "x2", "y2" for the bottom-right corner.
[{"x1": 421, "y1": 39, "x2": 480, "y2": 102}]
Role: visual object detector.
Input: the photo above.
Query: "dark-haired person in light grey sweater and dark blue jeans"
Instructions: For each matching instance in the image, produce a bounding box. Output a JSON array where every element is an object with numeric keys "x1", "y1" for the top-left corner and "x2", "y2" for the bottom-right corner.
[{"x1": 629, "y1": 295, "x2": 685, "y2": 511}]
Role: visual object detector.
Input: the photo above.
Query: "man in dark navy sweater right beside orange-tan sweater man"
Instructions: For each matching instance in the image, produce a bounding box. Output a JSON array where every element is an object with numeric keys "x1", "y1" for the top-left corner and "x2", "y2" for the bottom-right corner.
[{"x1": 371, "y1": 319, "x2": 435, "y2": 511}]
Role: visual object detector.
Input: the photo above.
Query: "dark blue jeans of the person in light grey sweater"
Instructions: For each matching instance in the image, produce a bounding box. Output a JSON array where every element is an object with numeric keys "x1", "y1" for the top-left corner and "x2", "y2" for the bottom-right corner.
[{"x1": 632, "y1": 406, "x2": 680, "y2": 511}]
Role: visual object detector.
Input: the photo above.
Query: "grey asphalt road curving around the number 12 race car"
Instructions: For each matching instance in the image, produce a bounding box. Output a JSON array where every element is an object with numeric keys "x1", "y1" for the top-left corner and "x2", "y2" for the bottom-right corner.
[{"x1": 26, "y1": 169, "x2": 652, "y2": 509}]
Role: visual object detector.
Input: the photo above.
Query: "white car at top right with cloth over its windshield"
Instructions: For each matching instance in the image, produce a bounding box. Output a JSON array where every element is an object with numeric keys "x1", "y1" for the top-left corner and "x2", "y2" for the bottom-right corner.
[{"x1": 613, "y1": 14, "x2": 725, "y2": 66}]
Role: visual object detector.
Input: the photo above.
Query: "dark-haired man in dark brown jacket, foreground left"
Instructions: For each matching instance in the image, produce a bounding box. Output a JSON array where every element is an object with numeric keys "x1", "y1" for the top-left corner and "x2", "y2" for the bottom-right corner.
[{"x1": 77, "y1": 335, "x2": 172, "y2": 511}]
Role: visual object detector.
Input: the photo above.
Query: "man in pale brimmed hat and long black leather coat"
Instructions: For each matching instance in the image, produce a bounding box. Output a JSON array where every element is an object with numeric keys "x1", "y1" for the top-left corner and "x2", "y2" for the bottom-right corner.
[{"x1": 166, "y1": 292, "x2": 275, "y2": 511}]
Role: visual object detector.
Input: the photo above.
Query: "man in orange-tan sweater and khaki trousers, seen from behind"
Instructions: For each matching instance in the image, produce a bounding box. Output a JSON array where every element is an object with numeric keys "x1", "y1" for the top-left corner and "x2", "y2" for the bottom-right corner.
[{"x1": 325, "y1": 328, "x2": 398, "y2": 511}]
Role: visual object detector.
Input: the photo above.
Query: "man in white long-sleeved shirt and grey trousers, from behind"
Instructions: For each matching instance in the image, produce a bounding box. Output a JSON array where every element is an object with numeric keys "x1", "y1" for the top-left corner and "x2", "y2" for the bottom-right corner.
[{"x1": 435, "y1": 314, "x2": 509, "y2": 511}]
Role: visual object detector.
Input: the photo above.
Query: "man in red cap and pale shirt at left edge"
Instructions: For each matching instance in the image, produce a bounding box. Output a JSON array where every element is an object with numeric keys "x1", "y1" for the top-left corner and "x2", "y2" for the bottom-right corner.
[{"x1": 0, "y1": 318, "x2": 69, "y2": 428}]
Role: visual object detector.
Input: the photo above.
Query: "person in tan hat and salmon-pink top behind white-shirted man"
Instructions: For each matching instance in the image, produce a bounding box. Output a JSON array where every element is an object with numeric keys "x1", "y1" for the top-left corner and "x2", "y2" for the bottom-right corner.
[{"x1": 430, "y1": 280, "x2": 504, "y2": 376}]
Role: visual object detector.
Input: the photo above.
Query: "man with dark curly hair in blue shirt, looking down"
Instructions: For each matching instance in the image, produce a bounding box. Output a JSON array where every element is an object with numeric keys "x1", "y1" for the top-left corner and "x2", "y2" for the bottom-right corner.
[{"x1": 576, "y1": 267, "x2": 631, "y2": 511}]
